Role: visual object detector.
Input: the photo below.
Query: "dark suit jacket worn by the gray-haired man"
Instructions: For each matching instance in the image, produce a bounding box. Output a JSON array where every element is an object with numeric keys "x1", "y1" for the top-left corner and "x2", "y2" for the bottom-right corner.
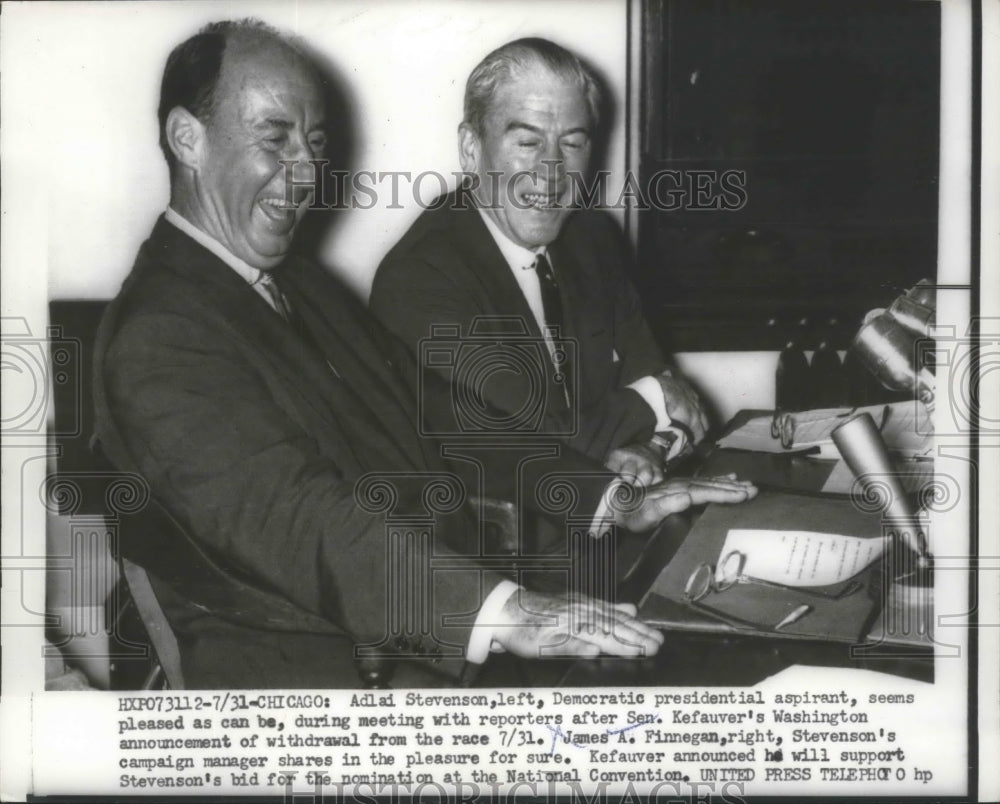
[{"x1": 370, "y1": 191, "x2": 666, "y2": 460}]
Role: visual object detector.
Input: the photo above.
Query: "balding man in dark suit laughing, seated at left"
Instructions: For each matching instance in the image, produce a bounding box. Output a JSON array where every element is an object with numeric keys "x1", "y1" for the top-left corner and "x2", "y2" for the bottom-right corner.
[{"x1": 94, "y1": 22, "x2": 753, "y2": 687}]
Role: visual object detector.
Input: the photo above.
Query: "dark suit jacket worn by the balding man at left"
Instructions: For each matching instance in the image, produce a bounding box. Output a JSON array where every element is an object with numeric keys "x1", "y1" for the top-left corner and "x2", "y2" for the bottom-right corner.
[{"x1": 94, "y1": 219, "x2": 607, "y2": 687}]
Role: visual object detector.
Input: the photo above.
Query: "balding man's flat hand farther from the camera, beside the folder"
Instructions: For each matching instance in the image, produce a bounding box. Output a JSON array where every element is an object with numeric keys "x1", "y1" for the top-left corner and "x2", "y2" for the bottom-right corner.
[{"x1": 613, "y1": 474, "x2": 757, "y2": 533}]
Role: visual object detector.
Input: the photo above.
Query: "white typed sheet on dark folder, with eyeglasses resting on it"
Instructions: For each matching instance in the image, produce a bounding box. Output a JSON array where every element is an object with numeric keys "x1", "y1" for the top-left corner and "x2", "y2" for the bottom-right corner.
[{"x1": 717, "y1": 528, "x2": 884, "y2": 586}]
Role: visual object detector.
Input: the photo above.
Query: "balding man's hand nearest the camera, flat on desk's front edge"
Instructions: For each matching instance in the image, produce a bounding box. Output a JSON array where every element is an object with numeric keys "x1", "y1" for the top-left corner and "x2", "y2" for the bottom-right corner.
[{"x1": 493, "y1": 589, "x2": 663, "y2": 659}]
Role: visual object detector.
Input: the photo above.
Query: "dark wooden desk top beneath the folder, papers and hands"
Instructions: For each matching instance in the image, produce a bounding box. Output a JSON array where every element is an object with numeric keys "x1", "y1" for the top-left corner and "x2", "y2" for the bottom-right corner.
[{"x1": 477, "y1": 411, "x2": 934, "y2": 687}]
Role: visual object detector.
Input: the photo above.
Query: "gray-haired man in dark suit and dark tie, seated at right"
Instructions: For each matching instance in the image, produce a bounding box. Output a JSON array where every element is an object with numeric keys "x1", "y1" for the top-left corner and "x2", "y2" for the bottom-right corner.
[{"x1": 371, "y1": 39, "x2": 706, "y2": 483}]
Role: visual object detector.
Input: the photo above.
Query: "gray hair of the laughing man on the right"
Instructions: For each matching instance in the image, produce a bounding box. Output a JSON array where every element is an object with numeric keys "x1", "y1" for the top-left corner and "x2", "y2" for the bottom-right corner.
[{"x1": 463, "y1": 38, "x2": 601, "y2": 135}]
